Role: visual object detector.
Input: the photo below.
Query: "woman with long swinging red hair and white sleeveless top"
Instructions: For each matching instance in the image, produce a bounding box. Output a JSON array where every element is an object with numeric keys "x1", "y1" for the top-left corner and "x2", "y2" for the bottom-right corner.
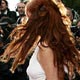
[{"x1": 1, "y1": 0, "x2": 79, "y2": 80}]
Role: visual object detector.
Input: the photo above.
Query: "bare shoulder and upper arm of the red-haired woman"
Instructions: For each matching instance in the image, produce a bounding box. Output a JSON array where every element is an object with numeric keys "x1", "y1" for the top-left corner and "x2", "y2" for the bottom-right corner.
[{"x1": 37, "y1": 45, "x2": 58, "y2": 80}]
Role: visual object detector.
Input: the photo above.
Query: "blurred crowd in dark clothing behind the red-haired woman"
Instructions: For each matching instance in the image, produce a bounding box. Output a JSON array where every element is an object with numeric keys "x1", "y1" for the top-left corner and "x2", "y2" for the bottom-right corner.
[{"x1": 0, "y1": 0, "x2": 80, "y2": 80}]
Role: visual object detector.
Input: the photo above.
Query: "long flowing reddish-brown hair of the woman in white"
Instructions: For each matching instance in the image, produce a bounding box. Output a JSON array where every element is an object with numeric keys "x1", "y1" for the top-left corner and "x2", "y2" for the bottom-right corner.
[{"x1": 1, "y1": 0, "x2": 79, "y2": 80}]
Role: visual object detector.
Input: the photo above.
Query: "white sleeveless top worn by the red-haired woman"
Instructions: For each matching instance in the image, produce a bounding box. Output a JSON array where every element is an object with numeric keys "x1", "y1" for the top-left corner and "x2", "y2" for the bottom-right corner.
[{"x1": 27, "y1": 47, "x2": 46, "y2": 80}]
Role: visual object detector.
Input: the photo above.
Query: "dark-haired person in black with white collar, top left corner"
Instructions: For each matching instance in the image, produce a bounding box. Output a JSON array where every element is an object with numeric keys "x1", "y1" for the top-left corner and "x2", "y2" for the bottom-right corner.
[{"x1": 0, "y1": 0, "x2": 17, "y2": 23}]
